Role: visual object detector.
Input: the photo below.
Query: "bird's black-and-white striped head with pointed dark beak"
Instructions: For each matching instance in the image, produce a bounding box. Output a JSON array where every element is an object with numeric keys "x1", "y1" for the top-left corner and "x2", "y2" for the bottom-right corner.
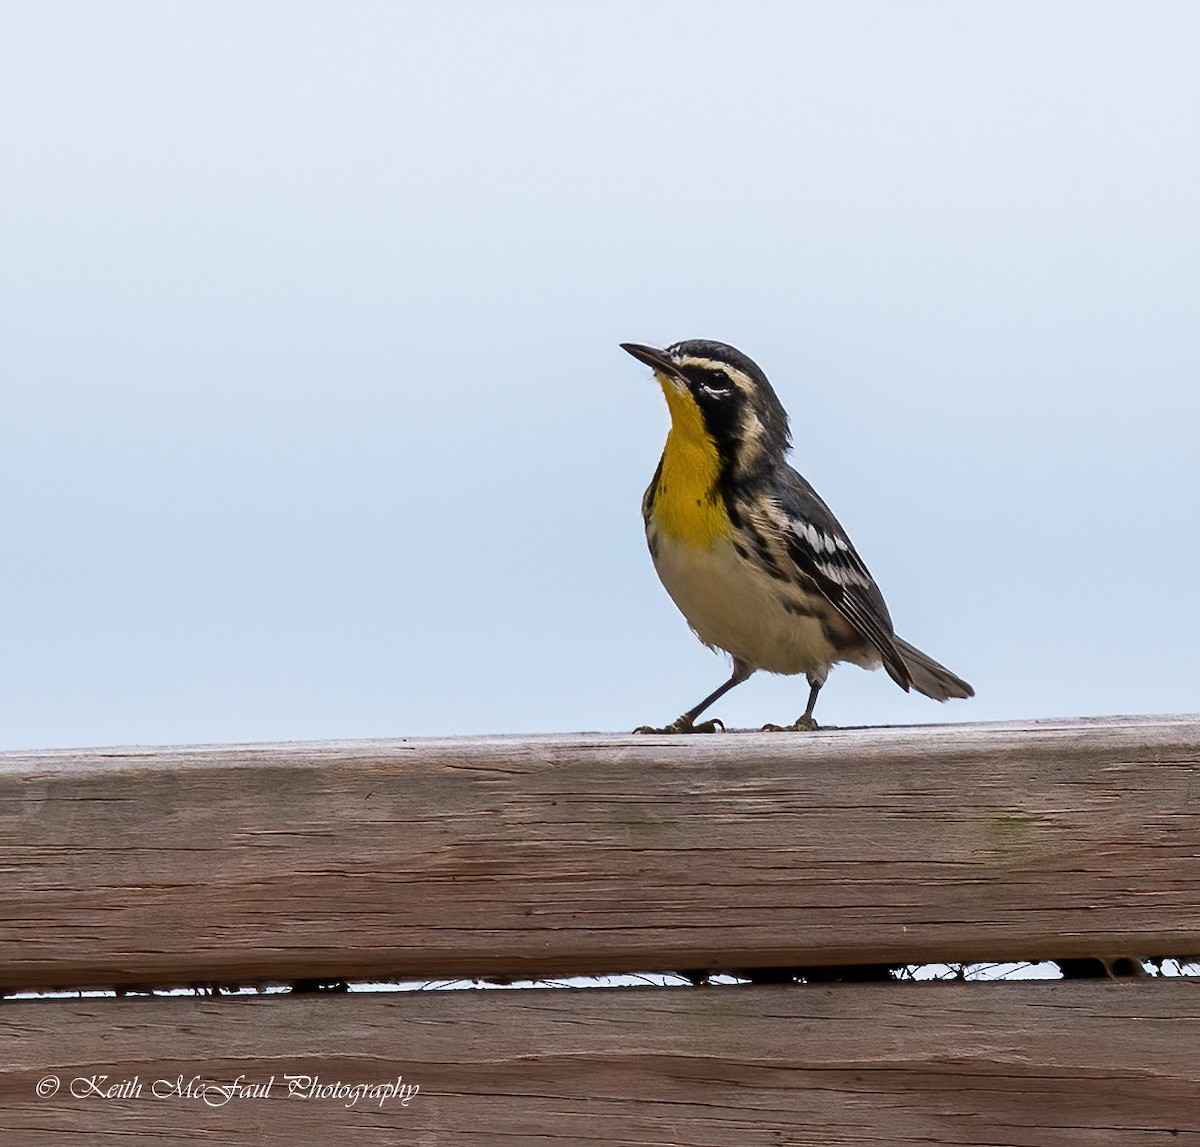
[{"x1": 620, "y1": 338, "x2": 788, "y2": 479}]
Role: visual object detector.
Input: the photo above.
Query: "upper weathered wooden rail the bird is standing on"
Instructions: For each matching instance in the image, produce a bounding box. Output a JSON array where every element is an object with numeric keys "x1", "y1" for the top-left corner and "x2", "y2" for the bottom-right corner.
[{"x1": 0, "y1": 717, "x2": 1200, "y2": 989}]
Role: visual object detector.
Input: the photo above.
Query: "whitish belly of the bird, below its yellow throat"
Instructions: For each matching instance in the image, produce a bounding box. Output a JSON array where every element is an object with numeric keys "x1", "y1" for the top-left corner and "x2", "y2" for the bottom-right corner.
[{"x1": 653, "y1": 534, "x2": 880, "y2": 680}]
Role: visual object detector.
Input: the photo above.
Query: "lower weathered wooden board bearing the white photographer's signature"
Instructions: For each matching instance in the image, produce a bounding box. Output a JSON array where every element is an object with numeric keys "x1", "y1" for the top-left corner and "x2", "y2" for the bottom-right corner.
[{"x1": 0, "y1": 980, "x2": 1200, "y2": 1147}]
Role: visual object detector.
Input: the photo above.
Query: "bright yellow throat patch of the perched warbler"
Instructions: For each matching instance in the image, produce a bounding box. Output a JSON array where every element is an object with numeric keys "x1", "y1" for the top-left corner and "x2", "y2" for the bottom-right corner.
[{"x1": 653, "y1": 372, "x2": 732, "y2": 546}]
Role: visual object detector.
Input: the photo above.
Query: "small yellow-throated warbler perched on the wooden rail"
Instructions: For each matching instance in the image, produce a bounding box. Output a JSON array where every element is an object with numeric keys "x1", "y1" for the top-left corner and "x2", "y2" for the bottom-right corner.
[{"x1": 620, "y1": 338, "x2": 974, "y2": 733}]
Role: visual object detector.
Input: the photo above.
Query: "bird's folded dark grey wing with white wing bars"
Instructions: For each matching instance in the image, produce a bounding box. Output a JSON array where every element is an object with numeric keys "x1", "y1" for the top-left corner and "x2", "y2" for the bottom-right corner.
[{"x1": 758, "y1": 467, "x2": 912, "y2": 689}]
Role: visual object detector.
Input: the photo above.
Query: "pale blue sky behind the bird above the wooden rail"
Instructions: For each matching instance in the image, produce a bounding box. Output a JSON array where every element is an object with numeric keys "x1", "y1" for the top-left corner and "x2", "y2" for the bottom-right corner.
[{"x1": 0, "y1": 0, "x2": 1200, "y2": 747}]
